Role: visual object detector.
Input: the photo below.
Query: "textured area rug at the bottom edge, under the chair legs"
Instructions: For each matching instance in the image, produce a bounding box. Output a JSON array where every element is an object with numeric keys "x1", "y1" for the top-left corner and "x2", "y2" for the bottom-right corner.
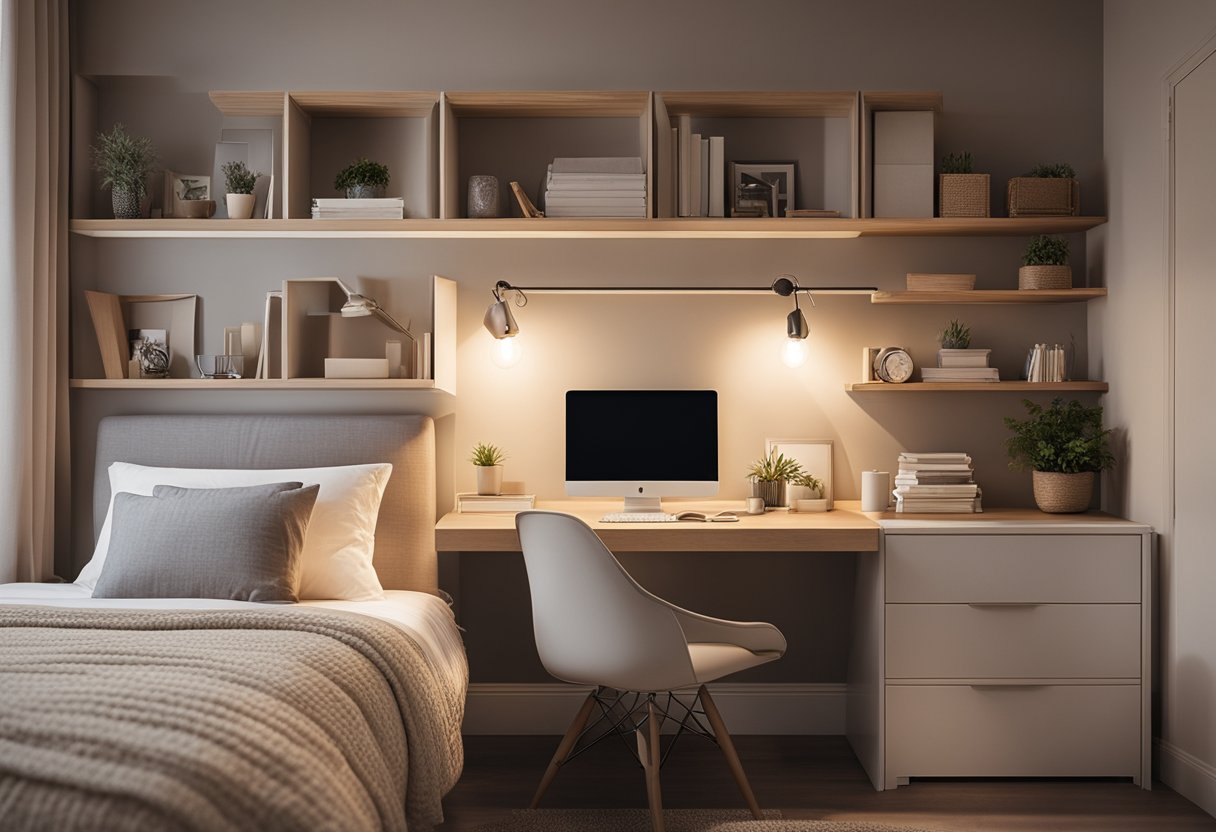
[{"x1": 477, "y1": 809, "x2": 931, "y2": 832}]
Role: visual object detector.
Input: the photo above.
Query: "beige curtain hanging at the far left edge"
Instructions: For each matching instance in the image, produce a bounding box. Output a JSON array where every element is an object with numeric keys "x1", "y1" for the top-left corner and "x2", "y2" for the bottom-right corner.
[{"x1": 0, "y1": 0, "x2": 68, "y2": 583}]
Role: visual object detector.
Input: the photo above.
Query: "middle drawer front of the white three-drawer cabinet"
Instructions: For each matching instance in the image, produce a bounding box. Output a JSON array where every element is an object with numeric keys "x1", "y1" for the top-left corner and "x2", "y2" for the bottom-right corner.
[{"x1": 886, "y1": 603, "x2": 1141, "y2": 679}]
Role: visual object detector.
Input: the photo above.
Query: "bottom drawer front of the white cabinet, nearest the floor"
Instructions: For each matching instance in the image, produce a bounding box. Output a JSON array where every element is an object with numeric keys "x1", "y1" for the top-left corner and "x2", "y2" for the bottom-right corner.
[{"x1": 886, "y1": 685, "x2": 1141, "y2": 785}]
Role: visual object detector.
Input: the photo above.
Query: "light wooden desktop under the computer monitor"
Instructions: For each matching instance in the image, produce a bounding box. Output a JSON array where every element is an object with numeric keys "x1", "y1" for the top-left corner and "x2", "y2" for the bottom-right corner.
[{"x1": 435, "y1": 500, "x2": 879, "y2": 552}]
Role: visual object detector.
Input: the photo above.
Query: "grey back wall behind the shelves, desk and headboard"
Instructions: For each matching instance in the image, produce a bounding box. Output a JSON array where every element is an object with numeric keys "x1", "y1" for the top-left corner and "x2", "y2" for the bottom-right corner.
[{"x1": 71, "y1": 0, "x2": 1104, "y2": 681}]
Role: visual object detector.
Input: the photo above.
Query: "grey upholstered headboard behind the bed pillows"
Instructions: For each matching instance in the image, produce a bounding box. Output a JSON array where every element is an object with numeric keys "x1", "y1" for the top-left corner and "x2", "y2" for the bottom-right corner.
[{"x1": 92, "y1": 415, "x2": 438, "y2": 592}]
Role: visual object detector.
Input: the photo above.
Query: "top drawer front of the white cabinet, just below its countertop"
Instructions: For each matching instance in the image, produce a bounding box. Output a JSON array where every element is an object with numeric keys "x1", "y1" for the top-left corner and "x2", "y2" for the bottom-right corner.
[{"x1": 885, "y1": 534, "x2": 1141, "y2": 603}]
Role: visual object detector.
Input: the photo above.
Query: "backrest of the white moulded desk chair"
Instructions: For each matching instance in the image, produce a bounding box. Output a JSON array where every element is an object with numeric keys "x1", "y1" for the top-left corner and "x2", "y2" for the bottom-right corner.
[{"x1": 516, "y1": 511, "x2": 696, "y2": 691}]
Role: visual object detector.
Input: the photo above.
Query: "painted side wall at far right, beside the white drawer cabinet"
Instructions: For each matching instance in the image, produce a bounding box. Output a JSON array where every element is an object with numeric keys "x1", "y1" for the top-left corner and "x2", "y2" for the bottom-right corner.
[{"x1": 1104, "y1": 0, "x2": 1216, "y2": 814}]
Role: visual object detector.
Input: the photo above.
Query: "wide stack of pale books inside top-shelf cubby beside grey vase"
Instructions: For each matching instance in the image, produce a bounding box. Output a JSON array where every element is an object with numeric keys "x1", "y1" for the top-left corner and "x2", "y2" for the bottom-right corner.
[{"x1": 545, "y1": 156, "x2": 646, "y2": 217}]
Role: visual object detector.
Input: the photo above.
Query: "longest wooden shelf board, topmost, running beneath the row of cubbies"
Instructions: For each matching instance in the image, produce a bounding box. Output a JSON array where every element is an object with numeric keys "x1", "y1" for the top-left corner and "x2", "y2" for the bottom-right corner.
[{"x1": 71, "y1": 217, "x2": 1107, "y2": 238}]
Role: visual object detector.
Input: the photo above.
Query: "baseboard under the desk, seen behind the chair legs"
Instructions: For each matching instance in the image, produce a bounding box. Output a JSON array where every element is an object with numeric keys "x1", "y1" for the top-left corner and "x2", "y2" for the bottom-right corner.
[{"x1": 463, "y1": 682, "x2": 848, "y2": 735}]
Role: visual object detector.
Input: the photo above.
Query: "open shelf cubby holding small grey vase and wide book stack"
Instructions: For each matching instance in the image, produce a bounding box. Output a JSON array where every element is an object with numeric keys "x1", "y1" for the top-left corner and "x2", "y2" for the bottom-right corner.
[{"x1": 439, "y1": 90, "x2": 653, "y2": 219}]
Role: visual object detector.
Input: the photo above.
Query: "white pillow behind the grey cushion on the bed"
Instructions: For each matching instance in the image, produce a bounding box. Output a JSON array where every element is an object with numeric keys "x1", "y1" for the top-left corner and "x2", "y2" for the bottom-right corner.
[{"x1": 75, "y1": 462, "x2": 393, "y2": 601}]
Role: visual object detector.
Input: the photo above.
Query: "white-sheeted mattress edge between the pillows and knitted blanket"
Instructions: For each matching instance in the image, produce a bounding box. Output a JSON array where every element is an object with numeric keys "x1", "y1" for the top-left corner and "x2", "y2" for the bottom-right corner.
[{"x1": 0, "y1": 584, "x2": 468, "y2": 698}]
